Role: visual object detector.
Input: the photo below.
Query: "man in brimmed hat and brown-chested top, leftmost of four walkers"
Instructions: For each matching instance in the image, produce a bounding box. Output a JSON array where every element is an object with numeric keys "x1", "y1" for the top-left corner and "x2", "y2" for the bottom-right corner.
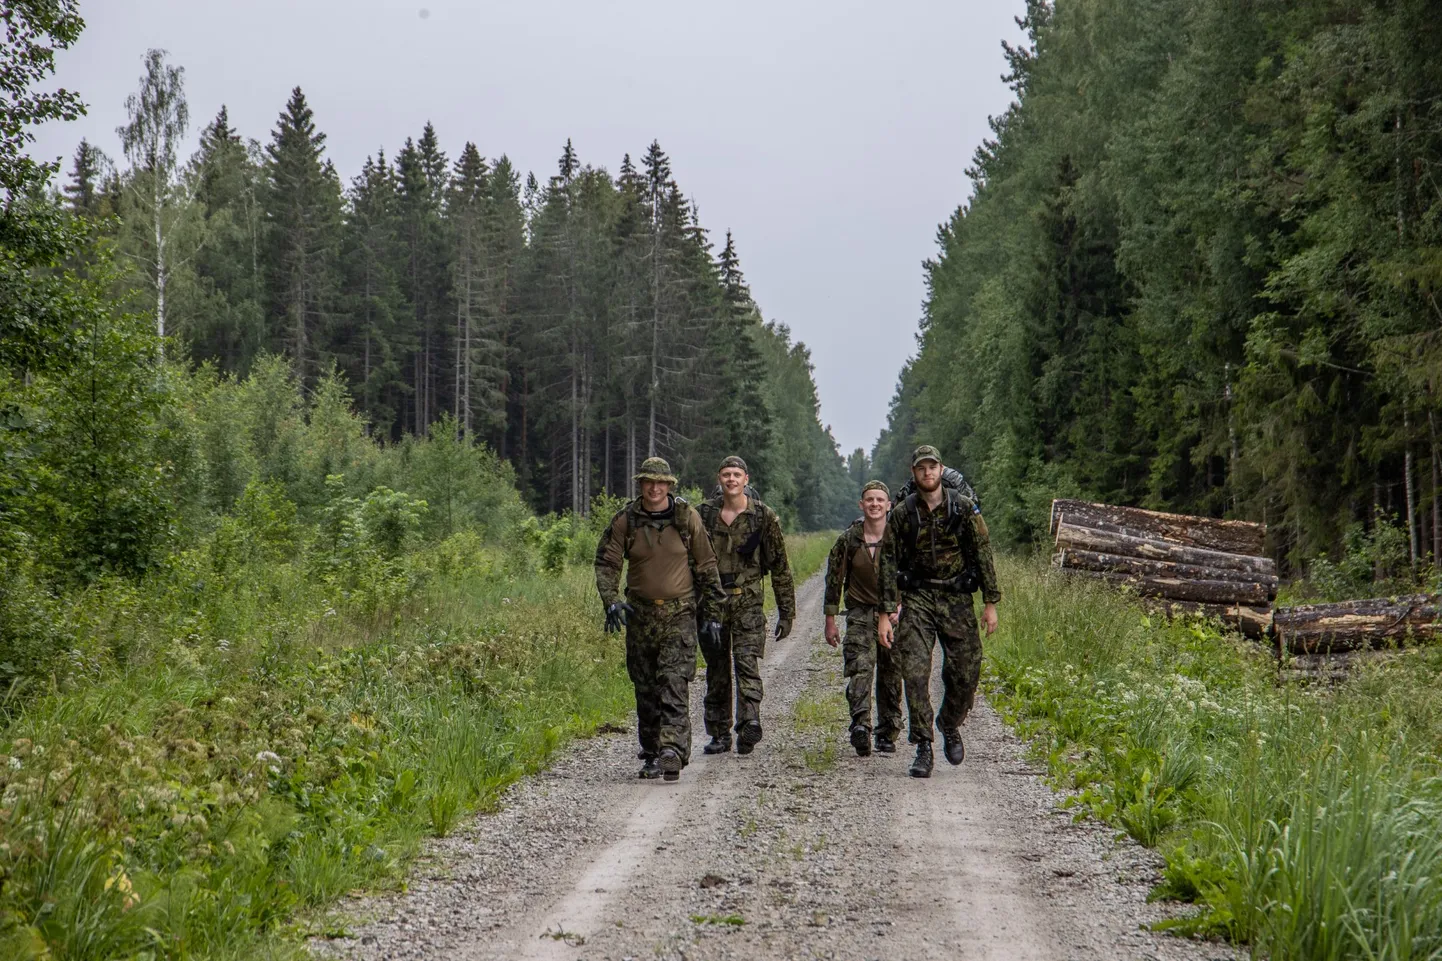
[{"x1": 596, "y1": 457, "x2": 721, "y2": 781}]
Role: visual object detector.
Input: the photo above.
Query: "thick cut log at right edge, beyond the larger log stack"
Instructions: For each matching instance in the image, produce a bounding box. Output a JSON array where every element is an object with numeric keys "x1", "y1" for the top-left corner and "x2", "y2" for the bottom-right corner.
[{"x1": 1276, "y1": 594, "x2": 1442, "y2": 654}]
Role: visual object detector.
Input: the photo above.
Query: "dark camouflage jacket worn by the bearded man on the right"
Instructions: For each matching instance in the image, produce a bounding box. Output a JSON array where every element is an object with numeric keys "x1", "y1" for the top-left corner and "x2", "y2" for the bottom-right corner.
[{"x1": 881, "y1": 491, "x2": 1001, "y2": 610}]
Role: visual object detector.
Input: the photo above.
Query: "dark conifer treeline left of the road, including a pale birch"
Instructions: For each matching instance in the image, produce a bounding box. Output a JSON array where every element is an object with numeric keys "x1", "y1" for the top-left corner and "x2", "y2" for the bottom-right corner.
[{"x1": 63, "y1": 51, "x2": 855, "y2": 528}]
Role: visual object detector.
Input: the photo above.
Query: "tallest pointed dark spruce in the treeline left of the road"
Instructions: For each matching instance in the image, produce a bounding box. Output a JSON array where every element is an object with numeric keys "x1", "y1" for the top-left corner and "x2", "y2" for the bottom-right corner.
[{"x1": 265, "y1": 87, "x2": 342, "y2": 382}]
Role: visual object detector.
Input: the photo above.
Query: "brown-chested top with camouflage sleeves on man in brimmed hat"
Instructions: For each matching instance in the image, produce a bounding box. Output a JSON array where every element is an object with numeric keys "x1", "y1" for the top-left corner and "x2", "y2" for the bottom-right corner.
[{"x1": 596, "y1": 498, "x2": 724, "y2": 620}]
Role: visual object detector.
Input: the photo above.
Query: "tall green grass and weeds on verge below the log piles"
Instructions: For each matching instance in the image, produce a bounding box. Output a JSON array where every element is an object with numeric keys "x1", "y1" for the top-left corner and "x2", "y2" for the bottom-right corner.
[{"x1": 986, "y1": 560, "x2": 1442, "y2": 961}]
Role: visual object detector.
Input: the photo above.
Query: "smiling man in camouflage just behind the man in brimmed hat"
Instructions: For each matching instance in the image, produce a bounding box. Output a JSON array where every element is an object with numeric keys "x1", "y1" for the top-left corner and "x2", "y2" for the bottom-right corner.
[{"x1": 696, "y1": 456, "x2": 796, "y2": 755}]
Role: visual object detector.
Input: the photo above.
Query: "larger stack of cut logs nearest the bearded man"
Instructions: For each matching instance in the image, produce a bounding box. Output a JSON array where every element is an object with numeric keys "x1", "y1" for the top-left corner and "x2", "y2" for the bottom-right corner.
[{"x1": 1051, "y1": 499, "x2": 1278, "y2": 638}]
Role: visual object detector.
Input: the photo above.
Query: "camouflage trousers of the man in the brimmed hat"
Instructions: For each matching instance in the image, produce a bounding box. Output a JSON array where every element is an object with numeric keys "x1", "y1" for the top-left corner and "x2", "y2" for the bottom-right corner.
[{"x1": 626, "y1": 597, "x2": 696, "y2": 762}]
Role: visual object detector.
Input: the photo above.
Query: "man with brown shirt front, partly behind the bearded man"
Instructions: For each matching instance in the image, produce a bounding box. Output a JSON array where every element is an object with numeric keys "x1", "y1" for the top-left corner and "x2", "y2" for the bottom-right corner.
[{"x1": 826, "y1": 481, "x2": 901, "y2": 758}]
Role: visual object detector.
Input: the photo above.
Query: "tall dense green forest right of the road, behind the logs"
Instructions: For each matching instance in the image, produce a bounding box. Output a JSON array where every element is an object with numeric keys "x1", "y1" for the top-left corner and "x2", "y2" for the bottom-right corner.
[{"x1": 874, "y1": 0, "x2": 1442, "y2": 567}]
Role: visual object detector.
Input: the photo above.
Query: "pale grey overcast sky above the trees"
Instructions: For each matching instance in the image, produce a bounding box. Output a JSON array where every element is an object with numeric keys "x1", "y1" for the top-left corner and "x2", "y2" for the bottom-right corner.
[{"x1": 37, "y1": 0, "x2": 1024, "y2": 453}]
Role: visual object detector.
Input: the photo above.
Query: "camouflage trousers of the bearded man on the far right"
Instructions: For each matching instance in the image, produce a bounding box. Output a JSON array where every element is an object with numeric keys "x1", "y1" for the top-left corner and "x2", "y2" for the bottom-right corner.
[{"x1": 894, "y1": 590, "x2": 982, "y2": 745}]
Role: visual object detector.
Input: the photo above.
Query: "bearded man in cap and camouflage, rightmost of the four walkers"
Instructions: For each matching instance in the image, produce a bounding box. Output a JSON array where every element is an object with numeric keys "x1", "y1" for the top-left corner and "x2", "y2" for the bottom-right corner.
[{"x1": 877, "y1": 446, "x2": 1001, "y2": 778}]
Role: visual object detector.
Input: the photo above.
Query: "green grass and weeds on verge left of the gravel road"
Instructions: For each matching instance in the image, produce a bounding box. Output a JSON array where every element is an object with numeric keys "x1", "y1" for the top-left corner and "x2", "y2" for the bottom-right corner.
[{"x1": 0, "y1": 505, "x2": 829, "y2": 960}]
